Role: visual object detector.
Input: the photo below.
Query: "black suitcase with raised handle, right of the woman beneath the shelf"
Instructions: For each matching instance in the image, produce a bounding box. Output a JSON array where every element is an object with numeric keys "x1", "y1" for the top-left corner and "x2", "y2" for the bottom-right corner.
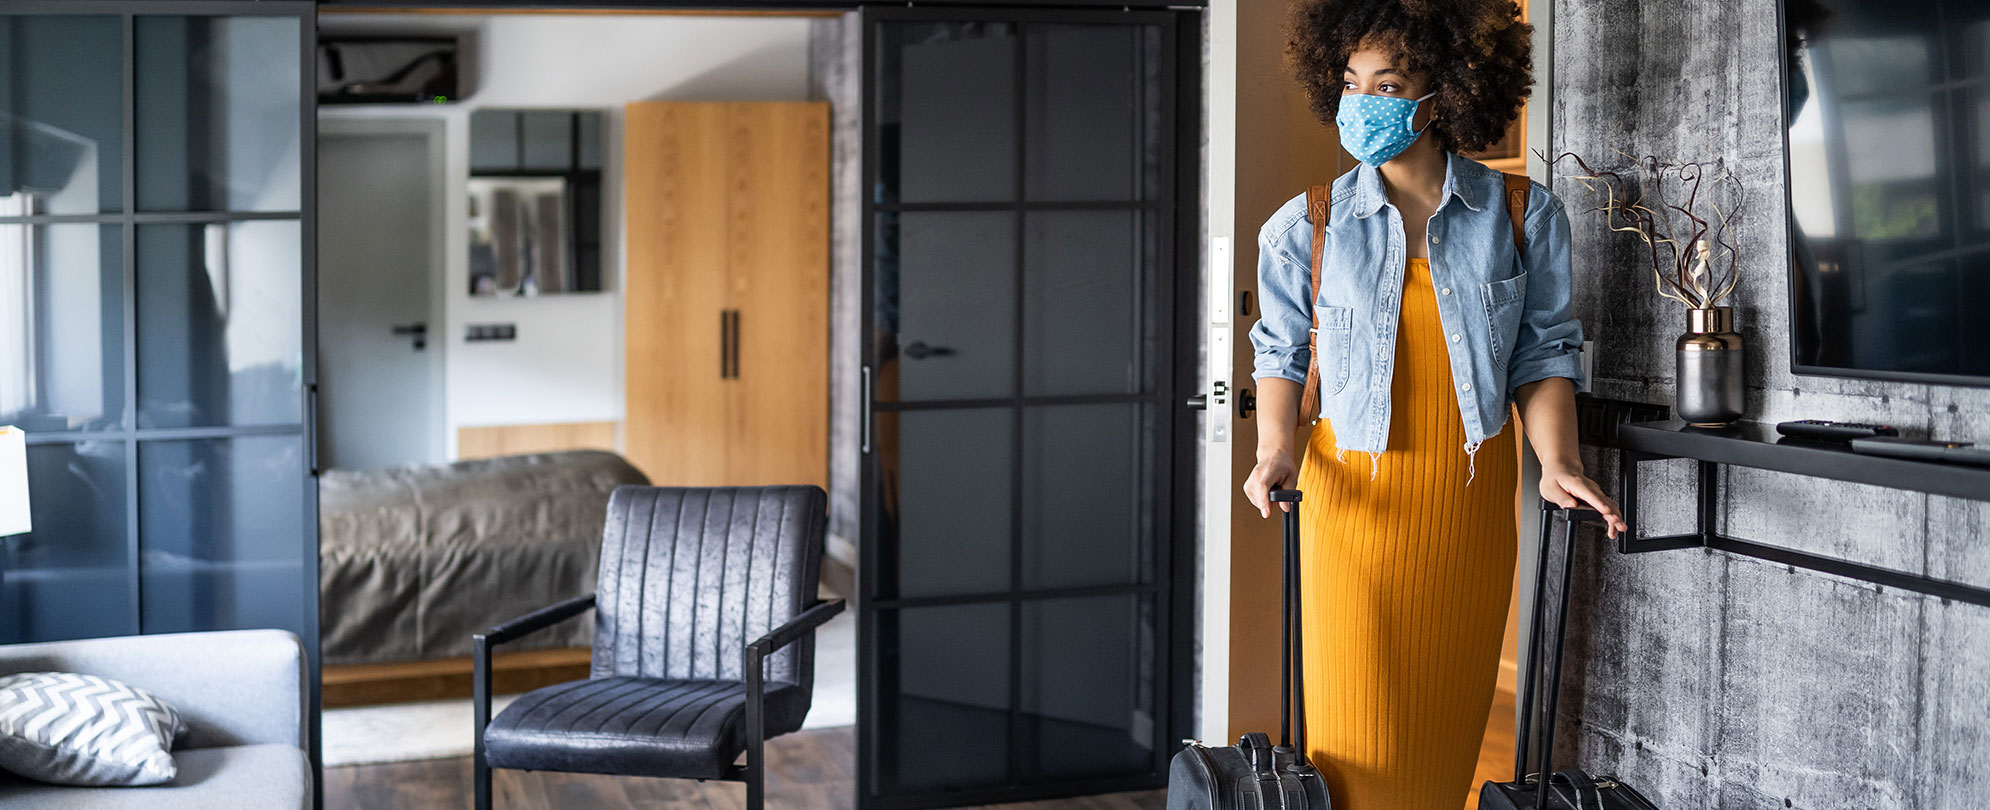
[{"x1": 1479, "y1": 500, "x2": 1658, "y2": 810}]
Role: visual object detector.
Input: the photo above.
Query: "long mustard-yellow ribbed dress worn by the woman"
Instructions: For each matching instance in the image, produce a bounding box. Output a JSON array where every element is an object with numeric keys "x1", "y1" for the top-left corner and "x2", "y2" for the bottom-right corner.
[{"x1": 1299, "y1": 259, "x2": 1518, "y2": 810}]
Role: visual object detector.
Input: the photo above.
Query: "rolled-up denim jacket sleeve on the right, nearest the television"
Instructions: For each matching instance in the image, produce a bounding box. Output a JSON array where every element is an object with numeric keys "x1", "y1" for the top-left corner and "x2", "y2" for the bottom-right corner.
[{"x1": 1506, "y1": 193, "x2": 1584, "y2": 396}]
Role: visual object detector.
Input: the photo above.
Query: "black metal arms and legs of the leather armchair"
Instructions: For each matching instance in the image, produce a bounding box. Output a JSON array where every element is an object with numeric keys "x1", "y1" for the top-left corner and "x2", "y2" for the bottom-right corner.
[{"x1": 472, "y1": 595, "x2": 844, "y2": 810}]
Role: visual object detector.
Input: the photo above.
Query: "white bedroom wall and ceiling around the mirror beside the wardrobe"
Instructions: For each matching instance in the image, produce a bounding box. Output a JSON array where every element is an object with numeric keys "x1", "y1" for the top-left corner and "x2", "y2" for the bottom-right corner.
[{"x1": 318, "y1": 14, "x2": 808, "y2": 458}]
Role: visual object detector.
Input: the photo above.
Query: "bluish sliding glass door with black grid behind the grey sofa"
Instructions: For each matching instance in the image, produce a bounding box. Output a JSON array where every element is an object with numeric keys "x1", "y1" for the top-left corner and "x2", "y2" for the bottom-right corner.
[{"x1": 0, "y1": 0, "x2": 318, "y2": 708}]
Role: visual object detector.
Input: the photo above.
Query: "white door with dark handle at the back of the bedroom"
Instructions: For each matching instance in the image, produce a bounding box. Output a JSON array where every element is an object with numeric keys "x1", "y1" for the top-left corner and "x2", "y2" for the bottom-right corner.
[{"x1": 318, "y1": 127, "x2": 446, "y2": 470}]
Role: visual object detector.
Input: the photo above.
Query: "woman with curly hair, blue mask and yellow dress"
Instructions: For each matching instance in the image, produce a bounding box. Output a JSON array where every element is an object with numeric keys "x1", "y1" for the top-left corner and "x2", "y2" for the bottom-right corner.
[{"x1": 1244, "y1": 0, "x2": 1626, "y2": 810}]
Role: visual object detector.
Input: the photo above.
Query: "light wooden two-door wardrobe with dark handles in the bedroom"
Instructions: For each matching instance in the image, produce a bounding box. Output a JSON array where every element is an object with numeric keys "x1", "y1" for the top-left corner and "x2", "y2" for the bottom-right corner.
[{"x1": 623, "y1": 101, "x2": 830, "y2": 486}]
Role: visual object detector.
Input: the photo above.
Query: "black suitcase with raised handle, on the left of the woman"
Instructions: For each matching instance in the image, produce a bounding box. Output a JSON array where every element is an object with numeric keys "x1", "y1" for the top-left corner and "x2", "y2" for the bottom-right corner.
[{"x1": 1168, "y1": 490, "x2": 1333, "y2": 810}]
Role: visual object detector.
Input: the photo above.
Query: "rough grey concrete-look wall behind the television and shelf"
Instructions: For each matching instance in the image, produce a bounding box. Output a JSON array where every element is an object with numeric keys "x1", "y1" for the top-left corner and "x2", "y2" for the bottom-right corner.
[{"x1": 1554, "y1": 0, "x2": 1990, "y2": 810}]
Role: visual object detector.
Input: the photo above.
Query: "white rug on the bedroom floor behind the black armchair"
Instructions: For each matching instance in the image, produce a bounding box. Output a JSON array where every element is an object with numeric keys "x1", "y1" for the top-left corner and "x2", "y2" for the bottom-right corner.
[{"x1": 322, "y1": 611, "x2": 858, "y2": 768}]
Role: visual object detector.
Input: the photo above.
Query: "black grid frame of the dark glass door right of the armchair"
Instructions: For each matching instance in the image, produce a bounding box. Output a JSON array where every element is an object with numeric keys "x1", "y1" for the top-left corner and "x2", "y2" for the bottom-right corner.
[{"x1": 856, "y1": 2, "x2": 1202, "y2": 810}]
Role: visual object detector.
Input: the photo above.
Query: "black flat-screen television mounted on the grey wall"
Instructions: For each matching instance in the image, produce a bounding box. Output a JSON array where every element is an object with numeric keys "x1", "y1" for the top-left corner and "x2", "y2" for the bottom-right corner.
[{"x1": 1781, "y1": 0, "x2": 1990, "y2": 386}]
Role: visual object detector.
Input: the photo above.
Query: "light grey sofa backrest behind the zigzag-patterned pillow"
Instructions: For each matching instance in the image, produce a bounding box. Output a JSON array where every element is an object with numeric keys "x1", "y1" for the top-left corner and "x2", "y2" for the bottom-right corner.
[{"x1": 0, "y1": 631, "x2": 310, "y2": 748}]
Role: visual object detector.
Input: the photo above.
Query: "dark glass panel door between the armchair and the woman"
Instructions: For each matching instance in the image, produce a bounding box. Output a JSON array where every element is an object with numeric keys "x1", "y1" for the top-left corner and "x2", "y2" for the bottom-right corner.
[{"x1": 858, "y1": 8, "x2": 1194, "y2": 808}]
